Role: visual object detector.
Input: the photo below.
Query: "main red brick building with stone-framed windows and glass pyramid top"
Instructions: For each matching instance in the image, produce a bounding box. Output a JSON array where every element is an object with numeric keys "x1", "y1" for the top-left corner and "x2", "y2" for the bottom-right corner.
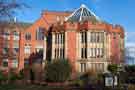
[{"x1": 1, "y1": 5, "x2": 124, "y2": 72}]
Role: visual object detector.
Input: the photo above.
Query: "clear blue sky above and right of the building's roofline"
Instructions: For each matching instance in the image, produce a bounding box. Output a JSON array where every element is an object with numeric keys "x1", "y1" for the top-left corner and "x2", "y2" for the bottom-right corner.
[{"x1": 17, "y1": 0, "x2": 135, "y2": 43}]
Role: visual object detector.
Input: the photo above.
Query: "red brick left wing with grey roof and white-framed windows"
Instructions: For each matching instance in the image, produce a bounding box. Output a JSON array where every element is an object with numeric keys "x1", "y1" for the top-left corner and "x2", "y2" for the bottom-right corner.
[{"x1": 0, "y1": 22, "x2": 29, "y2": 71}]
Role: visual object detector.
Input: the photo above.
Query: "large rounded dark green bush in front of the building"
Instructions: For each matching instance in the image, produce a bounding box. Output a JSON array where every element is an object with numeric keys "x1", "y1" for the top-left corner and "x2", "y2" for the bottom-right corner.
[{"x1": 45, "y1": 59, "x2": 72, "y2": 82}]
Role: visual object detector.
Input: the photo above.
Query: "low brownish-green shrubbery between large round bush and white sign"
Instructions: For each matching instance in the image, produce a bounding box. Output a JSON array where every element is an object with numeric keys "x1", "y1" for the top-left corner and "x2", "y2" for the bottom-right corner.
[{"x1": 69, "y1": 70, "x2": 104, "y2": 87}]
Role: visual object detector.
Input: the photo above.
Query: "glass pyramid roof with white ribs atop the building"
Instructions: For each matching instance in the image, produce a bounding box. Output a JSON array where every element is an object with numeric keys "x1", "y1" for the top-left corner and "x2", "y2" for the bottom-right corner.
[{"x1": 65, "y1": 4, "x2": 101, "y2": 22}]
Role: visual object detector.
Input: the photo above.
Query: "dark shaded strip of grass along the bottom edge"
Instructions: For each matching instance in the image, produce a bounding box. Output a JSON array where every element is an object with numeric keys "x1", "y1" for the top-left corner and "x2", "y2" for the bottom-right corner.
[{"x1": 0, "y1": 84, "x2": 128, "y2": 90}]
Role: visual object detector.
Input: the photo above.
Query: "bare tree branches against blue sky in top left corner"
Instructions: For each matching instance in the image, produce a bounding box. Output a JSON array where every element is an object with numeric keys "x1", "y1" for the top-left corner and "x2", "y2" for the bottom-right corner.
[{"x1": 0, "y1": 0, "x2": 28, "y2": 21}]
